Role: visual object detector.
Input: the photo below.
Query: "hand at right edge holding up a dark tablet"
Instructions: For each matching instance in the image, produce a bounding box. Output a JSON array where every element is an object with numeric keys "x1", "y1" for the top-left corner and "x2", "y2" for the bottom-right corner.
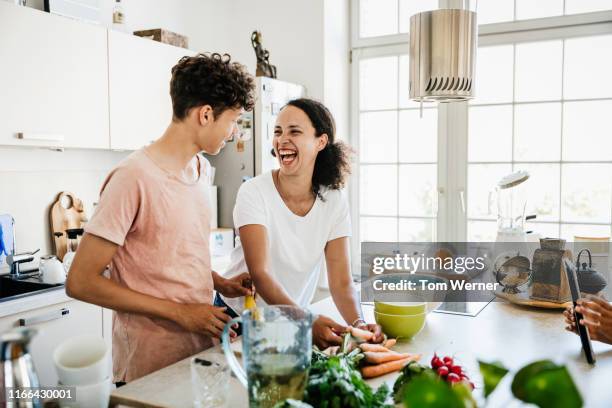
[{"x1": 563, "y1": 295, "x2": 612, "y2": 344}]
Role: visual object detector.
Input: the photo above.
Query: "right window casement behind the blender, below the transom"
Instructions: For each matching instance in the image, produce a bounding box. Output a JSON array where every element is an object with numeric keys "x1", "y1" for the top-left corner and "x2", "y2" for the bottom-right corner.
[{"x1": 467, "y1": 34, "x2": 612, "y2": 241}]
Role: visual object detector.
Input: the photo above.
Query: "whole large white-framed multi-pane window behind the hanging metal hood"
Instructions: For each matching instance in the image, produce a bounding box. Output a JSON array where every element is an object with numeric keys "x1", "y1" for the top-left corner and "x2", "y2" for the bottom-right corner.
[{"x1": 351, "y1": 0, "x2": 612, "y2": 259}]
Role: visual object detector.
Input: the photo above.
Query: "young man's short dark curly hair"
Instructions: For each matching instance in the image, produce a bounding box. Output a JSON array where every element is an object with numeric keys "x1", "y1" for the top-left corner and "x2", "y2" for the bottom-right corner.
[{"x1": 170, "y1": 53, "x2": 255, "y2": 120}]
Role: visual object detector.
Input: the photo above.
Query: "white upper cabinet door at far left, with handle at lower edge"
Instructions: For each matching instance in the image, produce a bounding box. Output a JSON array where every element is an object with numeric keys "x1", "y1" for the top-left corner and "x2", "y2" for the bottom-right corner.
[{"x1": 0, "y1": 1, "x2": 109, "y2": 149}]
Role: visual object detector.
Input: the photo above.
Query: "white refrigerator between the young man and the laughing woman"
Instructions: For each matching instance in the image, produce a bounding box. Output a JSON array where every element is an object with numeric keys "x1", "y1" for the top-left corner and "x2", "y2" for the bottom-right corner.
[{"x1": 206, "y1": 77, "x2": 306, "y2": 228}]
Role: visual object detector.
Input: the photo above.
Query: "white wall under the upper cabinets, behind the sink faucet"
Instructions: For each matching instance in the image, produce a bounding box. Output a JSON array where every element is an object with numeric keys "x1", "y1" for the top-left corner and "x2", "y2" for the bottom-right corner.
[{"x1": 0, "y1": 147, "x2": 127, "y2": 270}]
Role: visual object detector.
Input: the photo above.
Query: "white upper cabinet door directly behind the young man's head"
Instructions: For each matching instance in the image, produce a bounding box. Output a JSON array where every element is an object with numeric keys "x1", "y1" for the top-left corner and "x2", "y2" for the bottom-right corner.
[{"x1": 108, "y1": 31, "x2": 193, "y2": 150}]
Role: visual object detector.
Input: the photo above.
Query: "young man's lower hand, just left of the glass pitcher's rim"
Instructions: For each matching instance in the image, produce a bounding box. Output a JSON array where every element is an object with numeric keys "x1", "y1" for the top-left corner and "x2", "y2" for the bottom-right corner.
[{"x1": 174, "y1": 303, "x2": 236, "y2": 339}]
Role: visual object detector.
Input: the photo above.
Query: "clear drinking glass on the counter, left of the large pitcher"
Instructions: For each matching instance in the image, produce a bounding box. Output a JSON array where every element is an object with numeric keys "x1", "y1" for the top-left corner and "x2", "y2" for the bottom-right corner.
[{"x1": 191, "y1": 353, "x2": 230, "y2": 408}]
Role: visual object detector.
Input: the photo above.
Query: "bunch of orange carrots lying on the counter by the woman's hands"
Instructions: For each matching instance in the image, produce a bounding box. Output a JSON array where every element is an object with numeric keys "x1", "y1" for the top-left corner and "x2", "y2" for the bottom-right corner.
[{"x1": 323, "y1": 327, "x2": 421, "y2": 378}]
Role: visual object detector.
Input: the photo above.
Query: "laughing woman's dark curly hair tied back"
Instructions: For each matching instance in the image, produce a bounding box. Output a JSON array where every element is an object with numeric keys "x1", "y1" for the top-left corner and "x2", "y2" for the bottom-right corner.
[{"x1": 285, "y1": 98, "x2": 353, "y2": 200}]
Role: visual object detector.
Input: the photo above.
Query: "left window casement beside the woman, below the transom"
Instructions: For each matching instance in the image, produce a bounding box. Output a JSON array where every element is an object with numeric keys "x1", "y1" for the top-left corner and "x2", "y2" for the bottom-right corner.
[{"x1": 358, "y1": 52, "x2": 437, "y2": 242}]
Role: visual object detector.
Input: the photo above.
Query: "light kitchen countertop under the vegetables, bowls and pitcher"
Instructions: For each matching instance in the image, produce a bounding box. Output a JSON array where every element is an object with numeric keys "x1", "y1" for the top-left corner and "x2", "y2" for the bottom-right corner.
[{"x1": 111, "y1": 298, "x2": 612, "y2": 408}]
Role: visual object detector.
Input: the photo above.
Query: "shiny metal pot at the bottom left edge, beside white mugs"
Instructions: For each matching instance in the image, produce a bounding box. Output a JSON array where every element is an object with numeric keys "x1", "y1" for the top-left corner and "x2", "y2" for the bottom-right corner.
[{"x1": 0, "y1": 327, "x2": 42, "y2": 408}]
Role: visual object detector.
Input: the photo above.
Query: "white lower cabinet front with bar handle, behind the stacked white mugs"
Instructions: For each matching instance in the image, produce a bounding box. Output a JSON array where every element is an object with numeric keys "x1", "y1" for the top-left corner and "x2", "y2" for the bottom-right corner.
[{"x1": 0, "y1": 300, "x2": 102, "y2": 386}]
